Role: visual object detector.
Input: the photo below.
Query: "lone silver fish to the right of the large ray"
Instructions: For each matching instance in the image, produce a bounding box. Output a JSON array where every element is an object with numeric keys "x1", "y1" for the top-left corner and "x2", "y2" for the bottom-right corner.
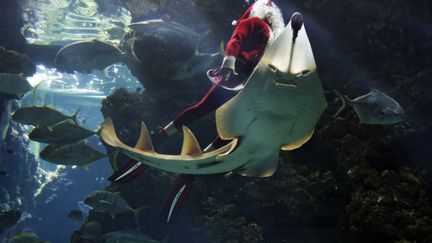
[{"x1": 334, "y1": 89, "x2": 406, "y2": 125}]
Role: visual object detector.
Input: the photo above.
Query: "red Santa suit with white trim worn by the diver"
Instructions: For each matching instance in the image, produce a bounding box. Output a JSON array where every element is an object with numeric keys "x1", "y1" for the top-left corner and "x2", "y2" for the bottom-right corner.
[{"x1": 160, "y1": 0, "x2": 285, "y2": 138}]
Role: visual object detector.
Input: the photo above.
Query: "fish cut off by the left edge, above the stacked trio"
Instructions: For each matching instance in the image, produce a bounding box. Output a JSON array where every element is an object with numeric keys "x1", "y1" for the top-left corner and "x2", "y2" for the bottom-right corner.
[{"x1": 0, "y1": 73, "x2": 33, "y2": 97}]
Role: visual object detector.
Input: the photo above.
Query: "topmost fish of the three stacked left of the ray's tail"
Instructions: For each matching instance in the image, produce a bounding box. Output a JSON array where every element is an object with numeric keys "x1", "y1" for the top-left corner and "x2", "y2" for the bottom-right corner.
[{"x1": 12, "y1": 106, "x2": 79, "y2": 126}]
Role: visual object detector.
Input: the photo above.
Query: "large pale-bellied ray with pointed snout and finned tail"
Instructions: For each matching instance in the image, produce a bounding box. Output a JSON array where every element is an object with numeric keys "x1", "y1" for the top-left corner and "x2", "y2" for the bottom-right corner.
[{"x1": 100, "y1": 16, "x2": 326, "y2": 177}]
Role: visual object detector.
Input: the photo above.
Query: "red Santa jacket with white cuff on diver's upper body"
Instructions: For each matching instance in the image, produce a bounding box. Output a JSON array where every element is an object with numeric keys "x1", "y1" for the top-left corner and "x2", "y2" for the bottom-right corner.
[{"x1": 222, "y1": 17, "x2": 270, "y2": 70}]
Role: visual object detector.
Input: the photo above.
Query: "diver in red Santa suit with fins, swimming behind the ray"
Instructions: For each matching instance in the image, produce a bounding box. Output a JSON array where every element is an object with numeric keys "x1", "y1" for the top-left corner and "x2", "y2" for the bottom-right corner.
[{"x1": 110, "y1": 0, "x2": 303, "y2": 223}]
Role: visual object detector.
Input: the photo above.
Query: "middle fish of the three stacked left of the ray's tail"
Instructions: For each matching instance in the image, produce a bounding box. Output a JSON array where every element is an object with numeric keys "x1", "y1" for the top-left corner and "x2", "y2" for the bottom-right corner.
[{"x1": 29, "y1": 119, "x2": 96, "y2": 143}]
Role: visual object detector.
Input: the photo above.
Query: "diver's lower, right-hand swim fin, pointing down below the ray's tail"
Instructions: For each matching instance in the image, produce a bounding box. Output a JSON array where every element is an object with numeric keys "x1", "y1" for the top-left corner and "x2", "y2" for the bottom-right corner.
[{"x1": 160, "y1": 175, "x2": 195, "y2": 224}]
